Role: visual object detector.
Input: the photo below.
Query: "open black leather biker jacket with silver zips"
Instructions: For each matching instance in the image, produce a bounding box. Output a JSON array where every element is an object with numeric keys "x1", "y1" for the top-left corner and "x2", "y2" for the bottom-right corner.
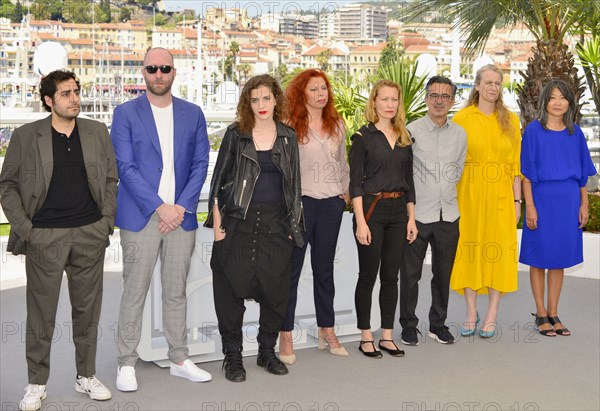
[{"x1": 204, "y1": 122, "x2": 304, "y2": 247}]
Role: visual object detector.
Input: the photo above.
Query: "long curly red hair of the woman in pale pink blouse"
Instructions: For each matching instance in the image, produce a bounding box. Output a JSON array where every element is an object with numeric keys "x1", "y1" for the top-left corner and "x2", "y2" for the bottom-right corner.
[{"x1": 285, "y1": 69, "x2": 342, "y2": 144}]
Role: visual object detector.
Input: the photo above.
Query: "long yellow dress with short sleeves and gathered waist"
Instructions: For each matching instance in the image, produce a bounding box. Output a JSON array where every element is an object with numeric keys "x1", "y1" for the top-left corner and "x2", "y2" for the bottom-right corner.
[{"x1": 450, "y1": 105, "x2": 521, "y2": 294}]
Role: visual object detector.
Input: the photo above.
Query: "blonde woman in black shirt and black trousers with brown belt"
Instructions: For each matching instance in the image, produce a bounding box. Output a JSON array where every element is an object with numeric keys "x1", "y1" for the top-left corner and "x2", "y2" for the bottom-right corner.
[{"x1": 350, "y1": 80, "x2": 417, "y2": 358}]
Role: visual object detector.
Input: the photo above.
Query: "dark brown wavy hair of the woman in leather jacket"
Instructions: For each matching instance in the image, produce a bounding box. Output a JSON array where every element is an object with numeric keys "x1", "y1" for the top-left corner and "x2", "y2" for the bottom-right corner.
[{"x1": 236, "y1": 74, "x2": 286, "y2": 134}]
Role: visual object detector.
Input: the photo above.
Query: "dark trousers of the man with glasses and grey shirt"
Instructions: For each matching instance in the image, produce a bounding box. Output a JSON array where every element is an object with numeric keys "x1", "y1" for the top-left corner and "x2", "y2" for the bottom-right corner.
[{"x1": 400, "y1": 219, "x2": 458, "y2": 329}]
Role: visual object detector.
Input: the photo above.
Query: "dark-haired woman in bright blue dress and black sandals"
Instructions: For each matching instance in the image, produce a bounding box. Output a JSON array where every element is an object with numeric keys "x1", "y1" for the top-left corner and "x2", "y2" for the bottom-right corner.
[{"x1": 515, "y1": 80, "x2": 596, "y2": 337}]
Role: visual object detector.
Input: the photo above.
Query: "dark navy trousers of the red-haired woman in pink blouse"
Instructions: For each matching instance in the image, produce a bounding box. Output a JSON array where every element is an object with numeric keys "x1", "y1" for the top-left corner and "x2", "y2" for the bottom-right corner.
[{"x1": 281, "y1": 196, "x2": 346, "y2": 331}]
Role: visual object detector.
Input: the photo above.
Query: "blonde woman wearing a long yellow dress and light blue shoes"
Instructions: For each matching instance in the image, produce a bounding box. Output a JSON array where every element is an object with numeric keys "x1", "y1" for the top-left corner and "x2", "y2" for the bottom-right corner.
[{"x1": 450, "y1": 64, "x2": 522, "y2": 338}]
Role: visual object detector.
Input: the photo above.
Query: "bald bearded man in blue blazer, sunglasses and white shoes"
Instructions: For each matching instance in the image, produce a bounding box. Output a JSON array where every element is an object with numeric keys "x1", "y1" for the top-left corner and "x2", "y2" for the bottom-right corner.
[{"x1": 111, "y1": 48, "x2": 212, "y2": 391}]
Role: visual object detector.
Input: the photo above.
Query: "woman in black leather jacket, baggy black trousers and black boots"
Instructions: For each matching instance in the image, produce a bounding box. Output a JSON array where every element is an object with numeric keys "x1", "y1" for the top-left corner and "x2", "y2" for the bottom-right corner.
[{"x1": 204, "y1": 74, "x2": 303, "y2": 382}]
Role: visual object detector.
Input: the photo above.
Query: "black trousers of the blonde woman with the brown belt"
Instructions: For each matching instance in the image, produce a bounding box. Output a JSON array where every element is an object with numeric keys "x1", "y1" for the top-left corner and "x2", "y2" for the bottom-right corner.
[{"x1": 354, "y1": 194, "x2": 408, "y2": 330}]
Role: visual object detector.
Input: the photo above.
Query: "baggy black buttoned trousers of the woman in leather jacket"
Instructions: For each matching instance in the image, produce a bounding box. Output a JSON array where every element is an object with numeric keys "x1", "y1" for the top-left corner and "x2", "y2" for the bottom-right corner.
[{"x1": 211, "y1": 204, "x2": 294, "y2": 352}]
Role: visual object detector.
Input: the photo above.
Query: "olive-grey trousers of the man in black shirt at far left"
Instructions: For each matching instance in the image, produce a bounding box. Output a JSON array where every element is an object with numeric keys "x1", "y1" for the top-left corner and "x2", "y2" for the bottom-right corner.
[{"x1": 25, "y1": 219, "x2": 109, "y2": 385}]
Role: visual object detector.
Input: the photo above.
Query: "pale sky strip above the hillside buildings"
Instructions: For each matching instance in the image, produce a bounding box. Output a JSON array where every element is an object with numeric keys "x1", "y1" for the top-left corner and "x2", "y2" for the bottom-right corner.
[{"x1": 163, "y1": 0, "x2": 358, "y2": 17}]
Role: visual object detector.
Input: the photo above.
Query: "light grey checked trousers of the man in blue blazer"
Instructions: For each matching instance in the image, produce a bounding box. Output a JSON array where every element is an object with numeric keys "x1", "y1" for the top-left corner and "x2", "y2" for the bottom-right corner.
[{"x1": 117, "y1": 214, "x2": 196, "y2": 366}]
